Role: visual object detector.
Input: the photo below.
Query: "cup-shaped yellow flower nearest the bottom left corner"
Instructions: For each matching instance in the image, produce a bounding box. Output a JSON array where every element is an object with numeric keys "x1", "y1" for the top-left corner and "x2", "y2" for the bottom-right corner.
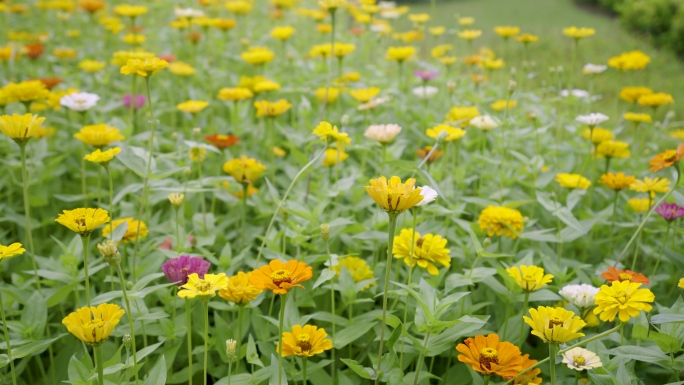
[{"x1": 62, "y1": 303, "x2": 125, "y2": 345}]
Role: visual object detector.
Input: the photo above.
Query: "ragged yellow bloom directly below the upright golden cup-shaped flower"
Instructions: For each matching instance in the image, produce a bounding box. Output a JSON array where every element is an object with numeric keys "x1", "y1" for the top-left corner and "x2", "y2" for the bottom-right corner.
[{"x1": 392, "y1": 229, "x2": 451, "y2": 275}]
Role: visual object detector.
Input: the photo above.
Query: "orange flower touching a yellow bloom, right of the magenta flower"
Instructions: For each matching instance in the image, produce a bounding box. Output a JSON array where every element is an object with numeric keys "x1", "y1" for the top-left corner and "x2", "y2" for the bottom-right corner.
[{"x1": 249, "y1": 260, "x2": 313, "y2": 294}]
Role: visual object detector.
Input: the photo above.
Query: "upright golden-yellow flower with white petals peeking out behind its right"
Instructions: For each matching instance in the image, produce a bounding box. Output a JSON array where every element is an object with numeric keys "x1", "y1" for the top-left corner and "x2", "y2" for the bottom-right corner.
[{"x1": 365, "y1": 176, "x2": 423, "y2": 215}]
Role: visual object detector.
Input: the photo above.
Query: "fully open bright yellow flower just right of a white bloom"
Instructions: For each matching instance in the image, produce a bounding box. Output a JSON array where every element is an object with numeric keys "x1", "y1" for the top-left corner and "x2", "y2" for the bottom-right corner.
[{"x1": 594, "y1": 281, "x2": 655, "y2": 322}]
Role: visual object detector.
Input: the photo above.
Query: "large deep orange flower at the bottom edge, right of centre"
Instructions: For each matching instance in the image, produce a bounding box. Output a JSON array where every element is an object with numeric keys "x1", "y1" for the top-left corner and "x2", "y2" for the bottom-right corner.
[{"x1": 456, "y1": 334, "x2": 526, "y2": 378}]
